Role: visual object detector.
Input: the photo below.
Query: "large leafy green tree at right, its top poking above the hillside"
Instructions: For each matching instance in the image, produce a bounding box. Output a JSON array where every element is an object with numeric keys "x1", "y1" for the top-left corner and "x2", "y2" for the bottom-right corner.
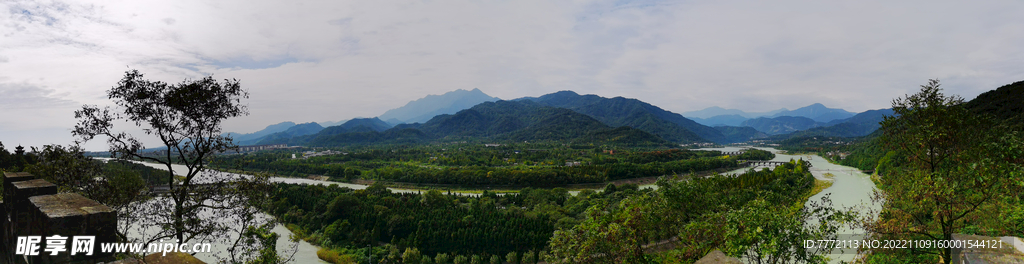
[{"x1": 868, "y1": 80, "x2": 1020, "y2": 261}]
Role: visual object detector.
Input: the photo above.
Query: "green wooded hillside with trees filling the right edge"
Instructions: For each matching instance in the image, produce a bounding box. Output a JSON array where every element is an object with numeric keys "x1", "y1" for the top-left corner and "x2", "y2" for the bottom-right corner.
[{"x1": 779, "y1": 80, "x2": 1024, "y2": 263}]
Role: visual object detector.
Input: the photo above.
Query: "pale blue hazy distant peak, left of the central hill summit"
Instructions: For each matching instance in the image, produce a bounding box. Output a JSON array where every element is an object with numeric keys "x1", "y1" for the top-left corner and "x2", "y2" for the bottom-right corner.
[{"x1": 378, "y1": 88, "x2": 500, "y2": 125}]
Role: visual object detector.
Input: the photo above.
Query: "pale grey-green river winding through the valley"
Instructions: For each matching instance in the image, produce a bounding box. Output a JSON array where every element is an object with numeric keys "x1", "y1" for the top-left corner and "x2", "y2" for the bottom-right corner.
[{"x1": 101, "y1": 147, "x2": 878, "y2": 263}]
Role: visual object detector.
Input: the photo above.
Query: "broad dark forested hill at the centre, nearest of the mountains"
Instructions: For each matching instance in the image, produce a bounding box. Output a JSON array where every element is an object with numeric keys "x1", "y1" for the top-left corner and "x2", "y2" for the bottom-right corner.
[{"x1": 261, "y1": 101, "x2": 672, "y2": 146}]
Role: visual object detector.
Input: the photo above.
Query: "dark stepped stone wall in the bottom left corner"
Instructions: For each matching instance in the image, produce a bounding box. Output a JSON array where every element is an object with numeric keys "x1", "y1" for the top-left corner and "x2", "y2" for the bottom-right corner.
[{"x1": 0, "y1": 172, "x2": 117, "y2": 264}]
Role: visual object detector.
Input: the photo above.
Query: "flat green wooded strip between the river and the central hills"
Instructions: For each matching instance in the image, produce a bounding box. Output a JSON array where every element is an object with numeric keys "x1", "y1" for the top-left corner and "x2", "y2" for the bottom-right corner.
[{"x1": 209, "y1": 144, "x2": 774, "y2": 187}]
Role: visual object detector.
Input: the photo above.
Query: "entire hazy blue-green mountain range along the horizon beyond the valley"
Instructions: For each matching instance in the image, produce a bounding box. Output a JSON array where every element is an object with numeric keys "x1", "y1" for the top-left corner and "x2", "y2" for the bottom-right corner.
[{"x1": 222, "y1": 89, "x2": 891, "y2": 146}]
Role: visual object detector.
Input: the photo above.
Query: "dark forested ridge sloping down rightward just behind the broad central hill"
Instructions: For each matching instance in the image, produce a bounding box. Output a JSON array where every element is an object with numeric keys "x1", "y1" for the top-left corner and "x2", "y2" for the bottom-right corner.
[{"x1": 518, "y1": 91, "x2": 729, "y2": 143}]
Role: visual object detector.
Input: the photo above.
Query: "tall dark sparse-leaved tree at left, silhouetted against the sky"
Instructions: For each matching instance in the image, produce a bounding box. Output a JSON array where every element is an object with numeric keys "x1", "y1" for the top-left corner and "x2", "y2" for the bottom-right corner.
[{"x1": 72, "y1": 70, "x2": 282, "y2": 260}]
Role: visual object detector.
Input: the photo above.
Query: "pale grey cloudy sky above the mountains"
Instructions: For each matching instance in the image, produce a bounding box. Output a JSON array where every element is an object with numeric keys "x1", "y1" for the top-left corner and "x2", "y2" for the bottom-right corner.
[{"x1": 0, "y1": 0, "x2": 1024, "y2": 149}]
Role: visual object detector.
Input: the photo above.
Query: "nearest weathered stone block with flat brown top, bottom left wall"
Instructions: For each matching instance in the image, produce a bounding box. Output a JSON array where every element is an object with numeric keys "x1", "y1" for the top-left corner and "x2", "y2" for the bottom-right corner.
[{"x1": 29, "y1": 193, "x2": 117, "y2": 263}]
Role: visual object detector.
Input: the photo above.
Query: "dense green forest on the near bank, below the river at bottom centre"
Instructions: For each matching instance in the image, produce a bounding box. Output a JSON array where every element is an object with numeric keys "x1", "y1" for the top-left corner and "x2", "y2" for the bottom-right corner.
[{"x1": 268, "y1": 158, "x2": 839, "y2": 263}]
